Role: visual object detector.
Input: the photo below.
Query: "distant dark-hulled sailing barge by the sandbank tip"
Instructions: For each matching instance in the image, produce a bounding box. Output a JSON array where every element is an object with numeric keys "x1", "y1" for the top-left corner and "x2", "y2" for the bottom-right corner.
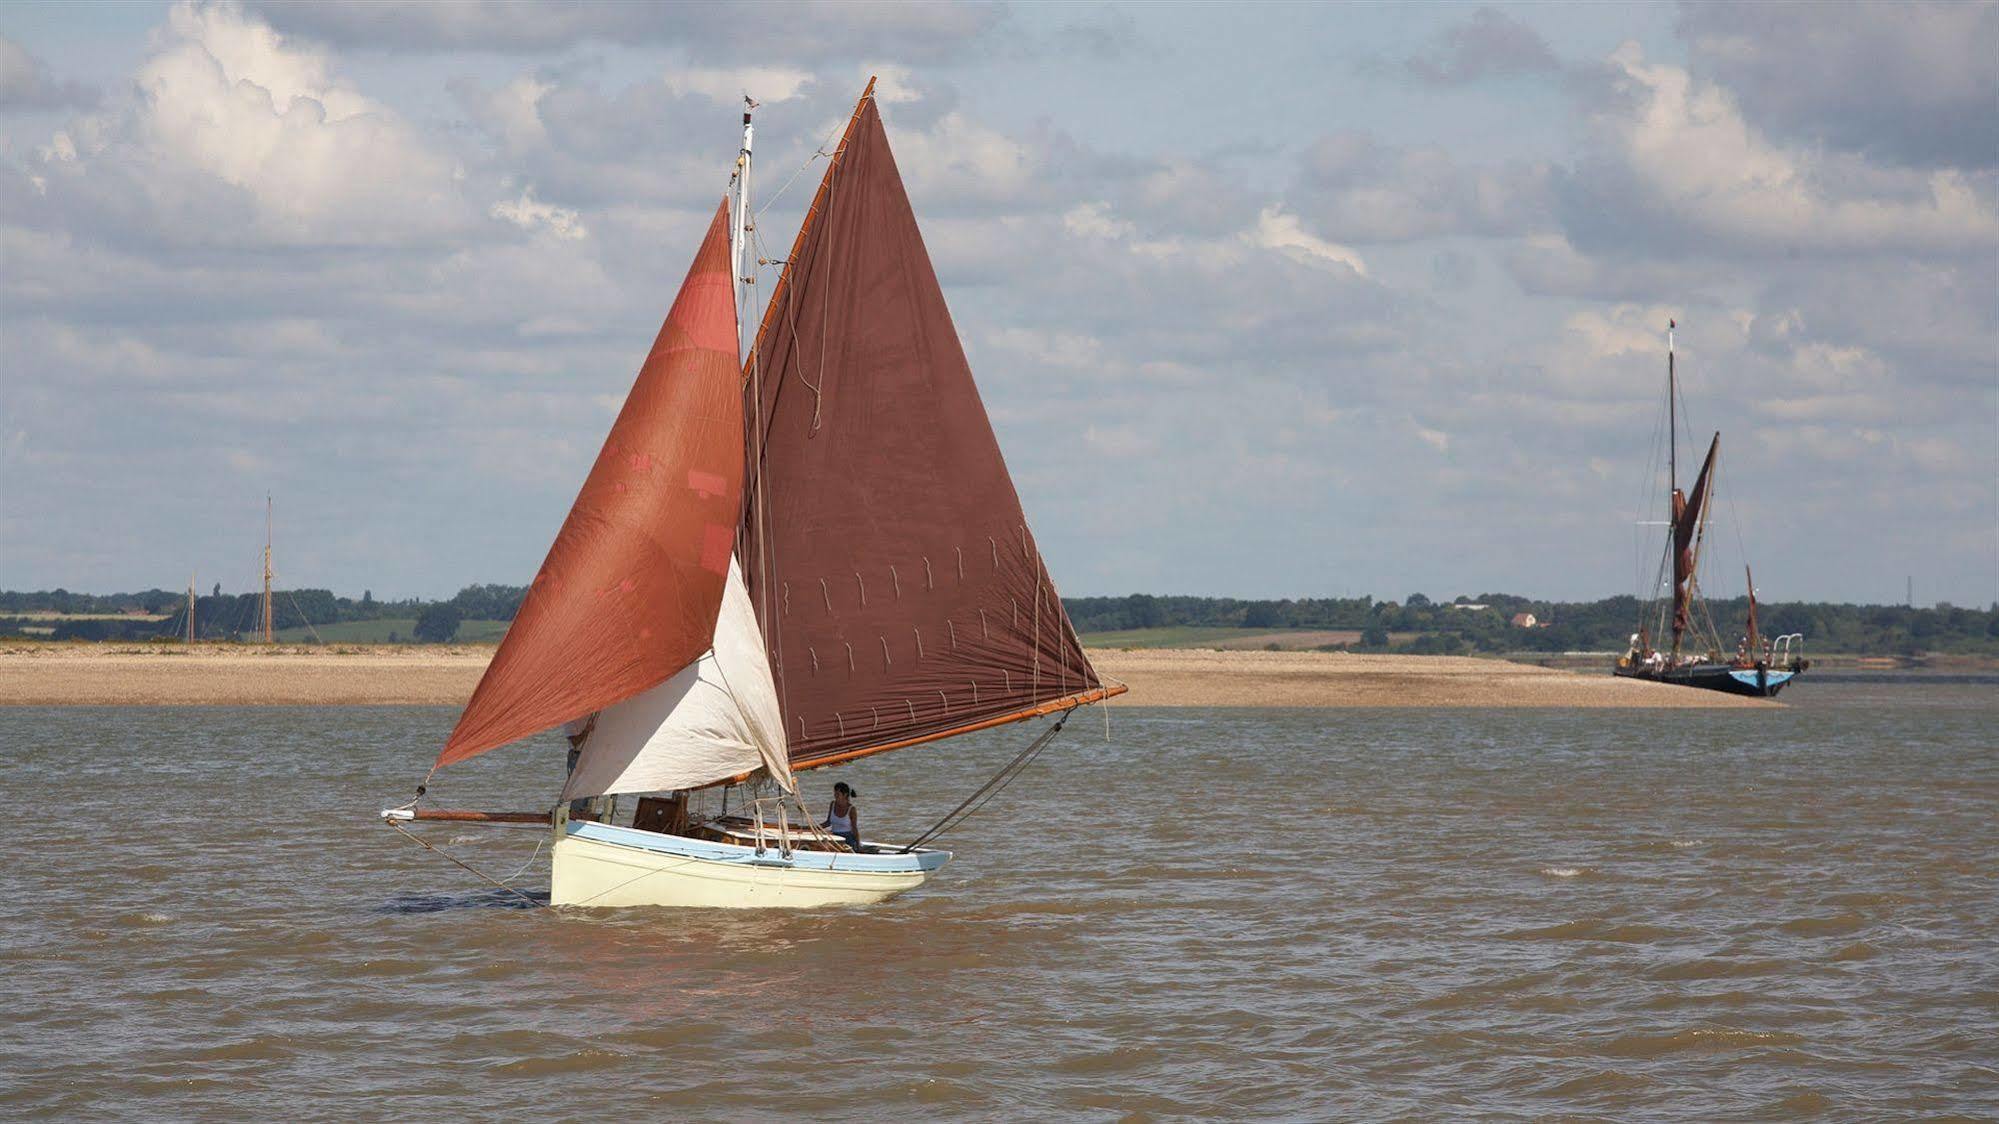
[{"x1": 1613, "y1": 320, "x2": 1811, "y2": 698}]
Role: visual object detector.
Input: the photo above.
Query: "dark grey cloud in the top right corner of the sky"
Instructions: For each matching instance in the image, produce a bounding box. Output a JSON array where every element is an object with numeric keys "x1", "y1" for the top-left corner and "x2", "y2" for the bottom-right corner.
[{"x1": 1679, "y1": 0, "x2": 1999, "y2": 168}]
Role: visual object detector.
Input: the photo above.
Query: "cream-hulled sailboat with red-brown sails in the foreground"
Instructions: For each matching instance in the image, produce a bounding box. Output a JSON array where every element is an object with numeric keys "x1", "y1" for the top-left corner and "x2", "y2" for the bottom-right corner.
[{"x1": 382, "y1": 80, "x2": 1125, "y2": 908}]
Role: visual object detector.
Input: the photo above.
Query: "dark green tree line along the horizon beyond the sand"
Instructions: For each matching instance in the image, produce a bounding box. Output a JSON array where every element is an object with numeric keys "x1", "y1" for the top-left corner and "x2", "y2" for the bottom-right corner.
[{"x1": 0, "y1": 584, "x2": 1999, "y2": 656}]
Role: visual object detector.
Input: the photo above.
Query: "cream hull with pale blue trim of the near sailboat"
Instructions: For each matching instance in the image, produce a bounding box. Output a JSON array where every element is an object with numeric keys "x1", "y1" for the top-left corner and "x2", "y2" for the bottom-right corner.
[{"x1": 548, "y1": 820, "x2": 952, "y2": 910}]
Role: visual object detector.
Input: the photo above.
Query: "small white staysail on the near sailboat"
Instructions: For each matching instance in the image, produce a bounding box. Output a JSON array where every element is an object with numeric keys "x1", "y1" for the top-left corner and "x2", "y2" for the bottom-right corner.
[{"x1": 562, "y1": 558, "x2": 796, "y2": 800}]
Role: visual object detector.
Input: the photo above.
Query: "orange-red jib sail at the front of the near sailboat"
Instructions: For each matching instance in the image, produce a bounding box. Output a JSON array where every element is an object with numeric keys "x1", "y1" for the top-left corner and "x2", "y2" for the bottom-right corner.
[{"x1": 438, "y1": 204, "x2": 744, "y2": 766}]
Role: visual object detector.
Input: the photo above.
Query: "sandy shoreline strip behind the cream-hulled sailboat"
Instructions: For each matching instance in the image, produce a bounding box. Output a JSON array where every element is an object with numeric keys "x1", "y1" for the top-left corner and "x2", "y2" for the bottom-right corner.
[{"x1": 0, "y1": 642, "x2": 1775, "y2": 708}]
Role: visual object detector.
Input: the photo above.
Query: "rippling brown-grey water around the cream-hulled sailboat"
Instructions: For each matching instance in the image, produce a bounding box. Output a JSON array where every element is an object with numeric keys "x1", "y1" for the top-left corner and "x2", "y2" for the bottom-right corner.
[{"x1": 0, "y1": 684, "x2": 1999, "y2": 1120}]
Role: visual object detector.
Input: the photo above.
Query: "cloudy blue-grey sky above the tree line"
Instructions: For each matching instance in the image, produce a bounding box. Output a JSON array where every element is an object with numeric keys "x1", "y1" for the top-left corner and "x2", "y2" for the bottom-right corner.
[{"x1": 0, "y1": 0, "x2": 1999, "y2": 604}]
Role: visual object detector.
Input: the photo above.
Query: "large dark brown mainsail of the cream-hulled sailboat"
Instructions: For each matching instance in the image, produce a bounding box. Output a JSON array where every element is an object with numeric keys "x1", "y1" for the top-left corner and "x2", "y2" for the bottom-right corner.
[{"x1": 742, "y1": 84, "x2": 1123, "y2": 768}]
